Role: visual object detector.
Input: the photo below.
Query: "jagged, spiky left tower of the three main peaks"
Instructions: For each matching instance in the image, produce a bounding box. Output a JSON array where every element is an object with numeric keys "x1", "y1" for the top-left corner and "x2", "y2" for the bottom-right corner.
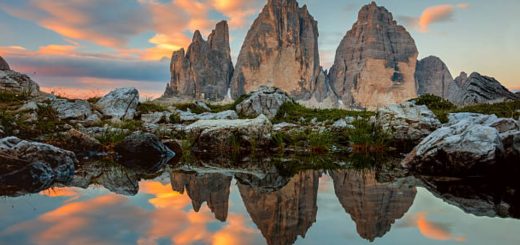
[{"x1": 165, "y1": 21, "x2": 233, "y2": 101}]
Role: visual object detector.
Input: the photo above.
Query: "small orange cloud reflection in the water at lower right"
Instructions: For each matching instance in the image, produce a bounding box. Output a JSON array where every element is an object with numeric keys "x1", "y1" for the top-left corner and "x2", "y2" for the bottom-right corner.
[{"x1": 416, "y1": 212, "x2": 465, "y2": 241}]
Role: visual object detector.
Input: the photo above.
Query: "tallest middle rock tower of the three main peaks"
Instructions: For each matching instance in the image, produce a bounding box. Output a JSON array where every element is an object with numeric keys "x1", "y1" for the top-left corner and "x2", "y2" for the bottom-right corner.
[{"x1": 231, "y1": 0, "x2": 320, "y2": 99}]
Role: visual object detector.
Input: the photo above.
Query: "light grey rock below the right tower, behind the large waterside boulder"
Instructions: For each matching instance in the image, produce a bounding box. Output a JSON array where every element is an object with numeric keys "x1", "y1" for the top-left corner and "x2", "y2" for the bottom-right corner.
[{"x1": 377, "y1": 102, "x2": 441, "y2": 142}]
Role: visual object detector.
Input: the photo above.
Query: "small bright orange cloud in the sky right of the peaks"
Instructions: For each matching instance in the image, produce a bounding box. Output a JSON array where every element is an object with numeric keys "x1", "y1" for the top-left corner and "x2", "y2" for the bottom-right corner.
[{"x1": 416, "y1": 3, "x2": 469, "y2": 32}]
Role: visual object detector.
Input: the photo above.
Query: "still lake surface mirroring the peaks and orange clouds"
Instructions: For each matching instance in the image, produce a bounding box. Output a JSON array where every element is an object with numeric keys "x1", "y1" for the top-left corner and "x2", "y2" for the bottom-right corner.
[{"x1": 0, "y1": 158, "x2": 520, "y2": 245}]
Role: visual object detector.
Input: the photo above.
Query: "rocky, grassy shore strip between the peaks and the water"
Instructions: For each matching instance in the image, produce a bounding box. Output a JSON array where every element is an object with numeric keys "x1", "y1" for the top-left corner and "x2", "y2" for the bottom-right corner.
[{"x1": 0, "y1": 83, "x2": 520, "y2": 194}]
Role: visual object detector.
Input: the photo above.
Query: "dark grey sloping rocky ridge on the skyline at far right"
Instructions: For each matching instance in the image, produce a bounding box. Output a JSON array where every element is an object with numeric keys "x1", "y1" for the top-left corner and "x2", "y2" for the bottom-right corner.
[{"x1": 450, "y1": 72, "x2": 520, "y2": 106}]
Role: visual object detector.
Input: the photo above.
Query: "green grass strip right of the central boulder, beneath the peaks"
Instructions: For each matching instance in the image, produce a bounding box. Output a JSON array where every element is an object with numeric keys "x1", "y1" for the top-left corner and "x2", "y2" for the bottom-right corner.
[{"x1": 273, "y1": 102, "x2": 375, "y2": 123}]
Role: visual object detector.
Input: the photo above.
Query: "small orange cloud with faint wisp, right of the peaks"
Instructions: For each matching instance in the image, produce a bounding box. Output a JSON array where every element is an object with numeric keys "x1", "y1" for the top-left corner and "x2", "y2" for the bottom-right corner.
[{"x1": 399, "y1": 3, "x2": 469, "y2": 32}]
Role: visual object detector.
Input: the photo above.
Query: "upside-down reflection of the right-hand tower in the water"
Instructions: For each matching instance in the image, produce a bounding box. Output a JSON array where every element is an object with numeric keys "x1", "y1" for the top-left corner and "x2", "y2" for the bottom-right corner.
[{"x1": 330, "y1": 170, "x2": 416, "y2": 241}]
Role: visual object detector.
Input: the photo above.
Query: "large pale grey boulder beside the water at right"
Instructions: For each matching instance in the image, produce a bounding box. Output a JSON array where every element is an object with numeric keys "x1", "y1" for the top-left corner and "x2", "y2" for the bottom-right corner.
[{"x1": 402, "y1": 120, "x2": 504, "y2": 175}]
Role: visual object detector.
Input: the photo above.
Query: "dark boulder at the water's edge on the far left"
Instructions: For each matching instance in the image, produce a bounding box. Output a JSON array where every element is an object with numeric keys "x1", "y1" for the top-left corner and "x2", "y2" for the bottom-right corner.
[{"x1": 0, "y1": 137, "x2": 78, "y2": 183}]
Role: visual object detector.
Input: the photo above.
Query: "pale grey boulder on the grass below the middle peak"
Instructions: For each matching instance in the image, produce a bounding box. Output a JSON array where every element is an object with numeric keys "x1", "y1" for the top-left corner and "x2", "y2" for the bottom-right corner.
[{"x1": 236, "y1": 86, "x2": 294, "y2": 119}]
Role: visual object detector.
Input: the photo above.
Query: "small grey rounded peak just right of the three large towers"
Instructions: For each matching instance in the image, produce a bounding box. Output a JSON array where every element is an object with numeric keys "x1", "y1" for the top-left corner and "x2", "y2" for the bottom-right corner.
[{"x1": 415, "y1": 56, "x2": 460, "y2": 99}]
